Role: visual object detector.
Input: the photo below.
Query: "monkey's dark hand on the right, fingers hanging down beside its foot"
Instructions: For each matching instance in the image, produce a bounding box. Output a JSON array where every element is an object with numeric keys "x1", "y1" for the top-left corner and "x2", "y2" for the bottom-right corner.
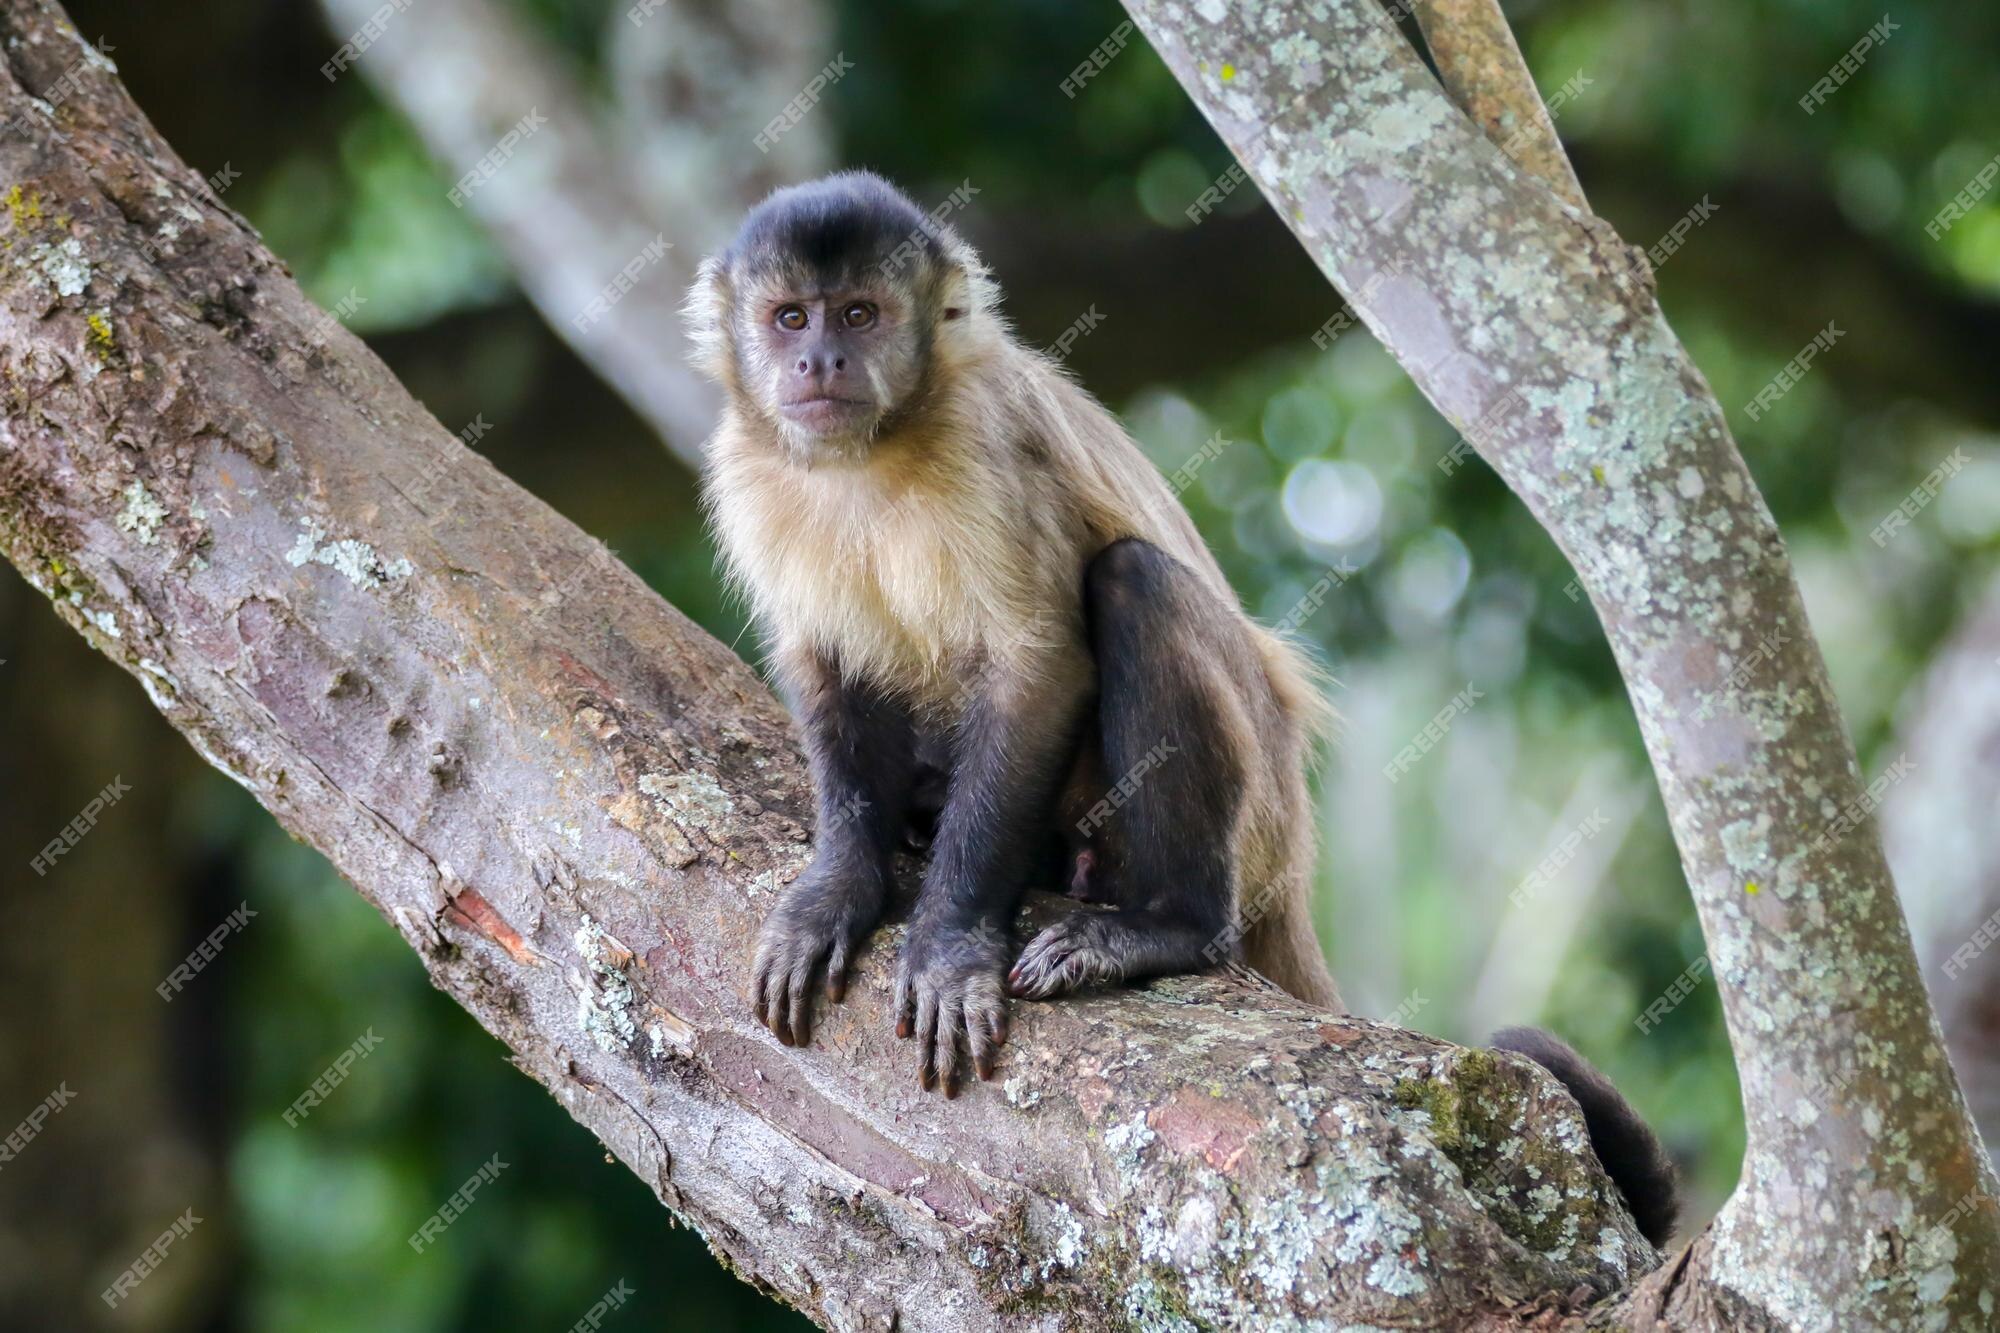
[{"x1": 896, "y1": 917, "x2": 1010, "y2": 1097}]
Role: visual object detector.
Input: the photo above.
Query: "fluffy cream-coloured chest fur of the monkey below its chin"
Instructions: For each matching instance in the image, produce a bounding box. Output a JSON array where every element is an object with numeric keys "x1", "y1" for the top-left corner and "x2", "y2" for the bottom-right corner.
[{"x1": 712, "y1": 452, "x2": 1078, "y2": 707}]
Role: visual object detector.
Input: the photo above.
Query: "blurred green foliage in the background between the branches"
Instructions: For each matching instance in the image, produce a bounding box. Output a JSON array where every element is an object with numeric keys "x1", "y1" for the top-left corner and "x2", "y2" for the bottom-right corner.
[{"x1": 58, "y1": 0, "x2": 2000, "y2": 1331}]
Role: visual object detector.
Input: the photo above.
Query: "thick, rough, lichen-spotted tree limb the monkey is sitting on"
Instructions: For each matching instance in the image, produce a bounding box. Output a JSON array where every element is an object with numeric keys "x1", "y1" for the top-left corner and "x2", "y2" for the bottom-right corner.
[{"x1": 0, "y1": 0, "x2": 1656, "y2": 1329}]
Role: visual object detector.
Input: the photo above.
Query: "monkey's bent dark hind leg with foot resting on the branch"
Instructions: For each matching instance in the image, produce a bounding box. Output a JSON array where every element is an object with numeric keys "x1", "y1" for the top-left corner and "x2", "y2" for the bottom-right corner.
[{"x1": 1008, "y1": 538, "x2": 1254, "y2": 999}]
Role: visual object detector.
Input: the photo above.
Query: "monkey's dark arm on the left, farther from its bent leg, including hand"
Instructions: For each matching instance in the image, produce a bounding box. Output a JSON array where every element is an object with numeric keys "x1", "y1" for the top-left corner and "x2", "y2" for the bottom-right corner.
[{"x1": 752, "y1": 656, "x2": 916, "y2": 1047}]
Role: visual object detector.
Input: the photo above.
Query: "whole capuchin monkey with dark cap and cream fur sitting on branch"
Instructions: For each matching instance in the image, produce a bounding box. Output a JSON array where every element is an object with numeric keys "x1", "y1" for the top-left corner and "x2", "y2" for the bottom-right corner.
[{"x1": 688, "y1": 172, "x2": 1664, "y2": 1240}]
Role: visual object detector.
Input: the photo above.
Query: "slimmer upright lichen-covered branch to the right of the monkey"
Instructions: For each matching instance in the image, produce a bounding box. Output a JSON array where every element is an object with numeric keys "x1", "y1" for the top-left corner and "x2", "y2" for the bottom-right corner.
[{"x1": 1126, "y1": 0, "x2": 2000, "y2": 1329}]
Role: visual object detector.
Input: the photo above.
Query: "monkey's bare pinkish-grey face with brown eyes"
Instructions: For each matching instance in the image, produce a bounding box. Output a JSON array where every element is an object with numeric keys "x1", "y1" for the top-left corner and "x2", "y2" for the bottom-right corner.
[{"x1": 738, "y1": 276, "x2": 922, "y2": 466}]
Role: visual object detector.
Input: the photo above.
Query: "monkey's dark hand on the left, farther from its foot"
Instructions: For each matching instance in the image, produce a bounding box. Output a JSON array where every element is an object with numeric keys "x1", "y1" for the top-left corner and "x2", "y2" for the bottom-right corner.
[{"x1": 750, "y1": 859, "x2": 888, "y2": 1047}]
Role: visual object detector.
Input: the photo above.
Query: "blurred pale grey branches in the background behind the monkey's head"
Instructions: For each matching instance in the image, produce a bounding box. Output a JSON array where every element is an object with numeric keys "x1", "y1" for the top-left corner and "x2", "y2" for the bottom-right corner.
[{"x1": 320, "y1": 0, "x2": 826, "y2": 468}]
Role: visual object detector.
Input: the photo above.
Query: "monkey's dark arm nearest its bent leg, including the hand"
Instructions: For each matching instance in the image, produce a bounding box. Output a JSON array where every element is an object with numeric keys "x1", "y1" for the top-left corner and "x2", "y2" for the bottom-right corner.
[{"x1": 896, "y1": 648, "x2": 1090, "y2": 1097}]
